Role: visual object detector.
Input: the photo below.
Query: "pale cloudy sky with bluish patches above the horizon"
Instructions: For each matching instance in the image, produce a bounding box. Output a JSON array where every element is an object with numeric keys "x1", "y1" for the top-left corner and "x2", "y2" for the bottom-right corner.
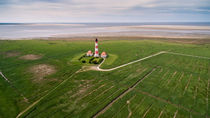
[{"x1": 0, "y1": 0, "x2": 210, "y2": 23}]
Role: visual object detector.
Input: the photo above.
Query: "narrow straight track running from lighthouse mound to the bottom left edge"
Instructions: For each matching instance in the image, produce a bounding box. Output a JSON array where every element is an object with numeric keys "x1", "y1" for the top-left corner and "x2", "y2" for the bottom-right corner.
[{"x1": 16, "y1": 69, "x2": 81, "y2": 118}]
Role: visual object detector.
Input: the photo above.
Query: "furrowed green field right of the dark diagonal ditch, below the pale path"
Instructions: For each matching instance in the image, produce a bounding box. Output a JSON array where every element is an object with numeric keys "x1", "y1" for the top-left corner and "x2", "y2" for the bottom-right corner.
[{"x1": 101, "y1": 55, "x2": 210, "y2": 118}]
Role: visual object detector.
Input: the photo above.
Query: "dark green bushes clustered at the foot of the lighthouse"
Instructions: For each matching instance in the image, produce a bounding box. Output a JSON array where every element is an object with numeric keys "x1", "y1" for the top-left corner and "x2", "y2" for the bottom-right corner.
[{"x1": 78, "y1": 55, "x2": 103, "y2": 64}]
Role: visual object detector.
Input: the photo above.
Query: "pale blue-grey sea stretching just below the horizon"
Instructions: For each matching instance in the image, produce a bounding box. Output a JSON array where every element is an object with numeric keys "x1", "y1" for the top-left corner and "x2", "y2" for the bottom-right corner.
[{"x1": 0, "y1": 22, "x2": 210, "y2": 40}]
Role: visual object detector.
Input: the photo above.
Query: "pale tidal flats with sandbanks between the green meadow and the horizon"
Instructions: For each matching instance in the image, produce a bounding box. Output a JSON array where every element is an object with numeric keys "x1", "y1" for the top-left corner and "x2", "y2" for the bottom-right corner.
[{"x1": 0, "y1": 24, "x2": 210, "y2": 40}]
